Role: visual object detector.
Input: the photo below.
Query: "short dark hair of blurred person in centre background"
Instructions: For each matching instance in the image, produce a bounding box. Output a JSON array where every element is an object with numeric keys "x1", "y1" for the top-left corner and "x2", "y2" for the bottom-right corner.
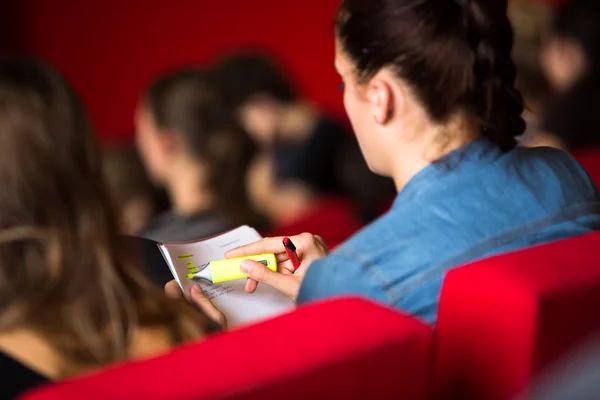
[{"x1": 214, "y1": 52, "x2": 297, "y2": 110}]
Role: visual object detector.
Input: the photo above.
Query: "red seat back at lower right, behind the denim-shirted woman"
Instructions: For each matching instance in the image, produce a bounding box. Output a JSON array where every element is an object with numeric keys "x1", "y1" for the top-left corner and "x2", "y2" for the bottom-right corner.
[{"x1": 435, "y1": 233, "x2": 600, "y2": 400}]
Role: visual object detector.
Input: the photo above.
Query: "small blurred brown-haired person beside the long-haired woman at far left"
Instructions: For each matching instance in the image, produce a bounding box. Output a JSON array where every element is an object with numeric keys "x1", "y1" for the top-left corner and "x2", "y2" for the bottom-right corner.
[{"x1": 102, "y1": 144, "x2": 167, "y2": 235}]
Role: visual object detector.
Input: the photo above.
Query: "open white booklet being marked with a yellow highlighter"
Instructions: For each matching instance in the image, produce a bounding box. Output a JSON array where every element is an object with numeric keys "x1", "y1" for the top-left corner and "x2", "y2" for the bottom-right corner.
[{"x1": 158, "y1": 226, "x2": 294, "y2": 327}]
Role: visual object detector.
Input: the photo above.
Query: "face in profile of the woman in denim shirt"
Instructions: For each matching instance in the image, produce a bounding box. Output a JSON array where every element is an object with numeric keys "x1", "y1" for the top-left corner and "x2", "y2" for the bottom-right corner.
[{"x1": 335, "y1": 43, "x2": 390, "y2": 175}]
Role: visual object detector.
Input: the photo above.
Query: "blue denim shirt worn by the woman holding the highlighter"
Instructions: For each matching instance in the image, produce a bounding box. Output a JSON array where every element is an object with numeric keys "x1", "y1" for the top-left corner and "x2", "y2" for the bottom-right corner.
[{"x1": 297, "y1": 139, "x2": 600, "y2": 323}]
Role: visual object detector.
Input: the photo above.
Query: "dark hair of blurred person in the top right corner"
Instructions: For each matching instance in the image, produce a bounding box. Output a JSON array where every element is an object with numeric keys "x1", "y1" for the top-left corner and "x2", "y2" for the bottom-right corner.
[{"x1": 553, "y1": 0, "x2": 600, "y2": 73}]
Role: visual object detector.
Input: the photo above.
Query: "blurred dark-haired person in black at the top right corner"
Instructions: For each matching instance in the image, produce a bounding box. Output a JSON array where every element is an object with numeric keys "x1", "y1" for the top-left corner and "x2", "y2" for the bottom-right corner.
[{"x1": 529, "y1": 0, "x2": 600, "y2": 154}]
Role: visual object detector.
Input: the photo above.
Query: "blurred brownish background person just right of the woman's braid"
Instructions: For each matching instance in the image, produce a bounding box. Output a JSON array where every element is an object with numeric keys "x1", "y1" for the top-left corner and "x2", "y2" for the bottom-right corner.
[{"x1": 508, "y1": 0, "x2": 552, "y2": 145}]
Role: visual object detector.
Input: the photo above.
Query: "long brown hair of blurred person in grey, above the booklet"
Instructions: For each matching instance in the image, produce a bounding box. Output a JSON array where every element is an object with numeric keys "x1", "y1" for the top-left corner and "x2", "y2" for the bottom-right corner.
[{"x1": 144, "y1": 69, "x2": 260, "y2": 225}]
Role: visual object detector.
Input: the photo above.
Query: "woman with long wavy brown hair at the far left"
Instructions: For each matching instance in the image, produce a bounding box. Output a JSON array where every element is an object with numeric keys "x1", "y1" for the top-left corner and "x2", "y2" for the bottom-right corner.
[{"x1": 0, "y1": 57, "x2": 223, "y2": 398}]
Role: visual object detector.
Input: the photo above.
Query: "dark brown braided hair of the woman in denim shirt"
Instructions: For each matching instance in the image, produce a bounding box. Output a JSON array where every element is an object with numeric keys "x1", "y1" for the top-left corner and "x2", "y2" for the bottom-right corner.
[{"x1": 336, "y1": 0, "x2": 525, "y2": 151}]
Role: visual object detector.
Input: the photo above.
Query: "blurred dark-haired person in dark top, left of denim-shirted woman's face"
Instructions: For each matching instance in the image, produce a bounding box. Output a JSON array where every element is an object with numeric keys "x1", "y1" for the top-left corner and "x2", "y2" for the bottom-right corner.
[{"x1": 215, "y1": 52, "x2": 393, "y2": 242}]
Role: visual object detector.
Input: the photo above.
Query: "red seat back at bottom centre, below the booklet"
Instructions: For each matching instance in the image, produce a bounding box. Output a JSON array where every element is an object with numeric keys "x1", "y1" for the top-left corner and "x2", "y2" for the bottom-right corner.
[{"x1": 25, "y1": 299, "x2": 432, "y2": 400}]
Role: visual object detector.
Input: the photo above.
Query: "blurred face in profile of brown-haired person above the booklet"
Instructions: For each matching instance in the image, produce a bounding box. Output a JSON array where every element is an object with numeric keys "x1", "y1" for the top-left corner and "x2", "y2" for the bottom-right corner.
[{"x1": 135, "y1": 105, "x2": 169, "y2": 183}]
